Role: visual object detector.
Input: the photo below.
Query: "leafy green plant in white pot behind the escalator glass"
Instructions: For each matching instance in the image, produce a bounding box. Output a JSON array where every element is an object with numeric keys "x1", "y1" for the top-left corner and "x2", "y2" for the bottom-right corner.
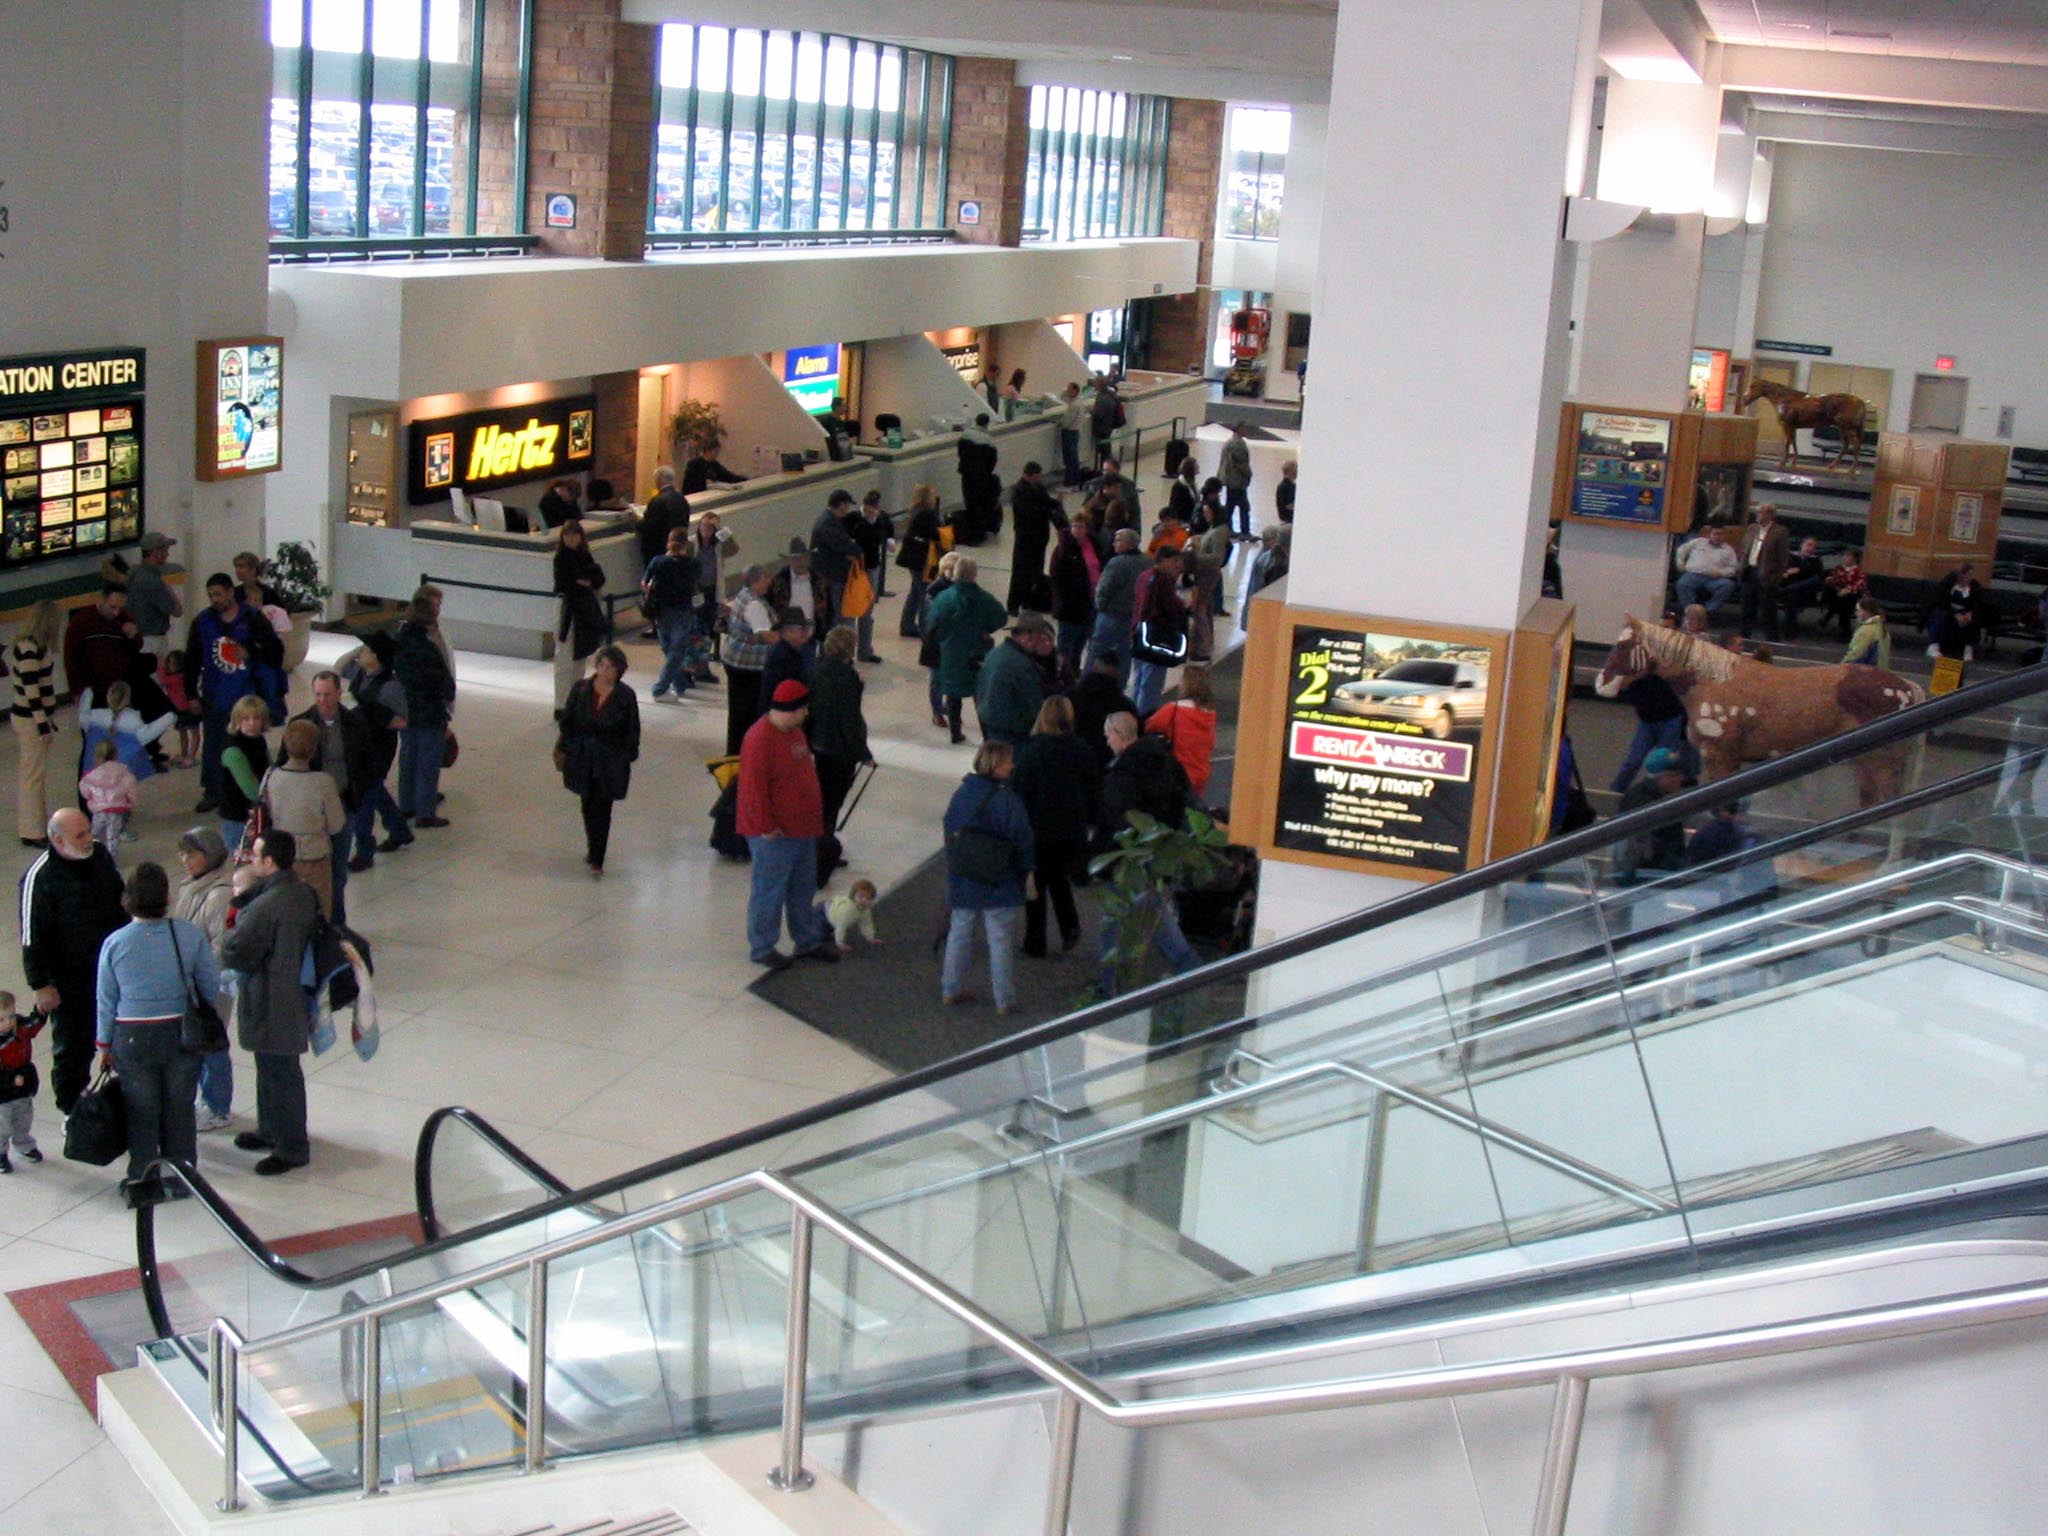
[{"x1": 1081, "y1": 809, "x2": 1231, "y2": 1122}]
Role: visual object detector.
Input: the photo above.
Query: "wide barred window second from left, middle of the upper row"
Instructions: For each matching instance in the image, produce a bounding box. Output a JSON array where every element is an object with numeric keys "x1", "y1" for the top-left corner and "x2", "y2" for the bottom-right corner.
[{"x1": 647, "y1": 25, "x2": 952, "y2": 236}]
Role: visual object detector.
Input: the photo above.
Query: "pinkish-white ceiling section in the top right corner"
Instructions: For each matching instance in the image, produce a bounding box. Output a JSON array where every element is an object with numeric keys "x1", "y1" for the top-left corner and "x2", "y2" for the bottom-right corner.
[{"x1": 1694, "y1": 0, "x2": 2048, "y2": 63}]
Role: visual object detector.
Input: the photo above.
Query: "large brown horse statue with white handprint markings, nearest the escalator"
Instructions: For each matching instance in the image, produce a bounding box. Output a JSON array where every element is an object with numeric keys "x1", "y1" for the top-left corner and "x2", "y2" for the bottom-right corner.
[{"x1": 1593, "y1": 616, "x2": 1927, "y2": 807}]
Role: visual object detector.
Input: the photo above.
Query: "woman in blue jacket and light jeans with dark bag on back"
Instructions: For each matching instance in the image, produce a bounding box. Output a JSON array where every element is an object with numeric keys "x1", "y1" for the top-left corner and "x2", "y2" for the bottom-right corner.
[{"x1": 938, "y1": 741, "x2": 1036, "y2": 1014}]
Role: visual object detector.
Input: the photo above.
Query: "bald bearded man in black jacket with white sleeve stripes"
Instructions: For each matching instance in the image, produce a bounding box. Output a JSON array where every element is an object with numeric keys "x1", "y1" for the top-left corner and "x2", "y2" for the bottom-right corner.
[{"x1": 20, "y1": 809, "x2": 127, "y2": 1114}]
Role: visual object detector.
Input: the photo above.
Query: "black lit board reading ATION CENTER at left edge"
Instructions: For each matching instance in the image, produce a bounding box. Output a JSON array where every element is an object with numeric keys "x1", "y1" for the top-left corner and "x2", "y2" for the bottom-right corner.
[{"x1": 0, "y1": 346, "x2": 143, "y2": 567}]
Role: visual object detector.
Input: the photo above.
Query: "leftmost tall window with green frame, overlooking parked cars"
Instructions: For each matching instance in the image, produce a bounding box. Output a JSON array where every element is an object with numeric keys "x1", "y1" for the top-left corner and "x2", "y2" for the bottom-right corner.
[{"x1": 270, "y1": 0, "x2": 530, "y2": 240}]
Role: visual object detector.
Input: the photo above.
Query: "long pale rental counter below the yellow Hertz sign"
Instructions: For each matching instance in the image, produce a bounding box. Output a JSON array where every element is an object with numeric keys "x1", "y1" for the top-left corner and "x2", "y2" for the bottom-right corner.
[{"x1": 334, "y1": 461, "x2": 874, "y2": 659}]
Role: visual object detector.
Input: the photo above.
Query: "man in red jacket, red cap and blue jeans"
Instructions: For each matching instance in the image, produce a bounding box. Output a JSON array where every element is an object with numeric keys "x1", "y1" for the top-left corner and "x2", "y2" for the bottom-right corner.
[{"x1": 737, "y1": 678, "x2": 840, "y2": 969}]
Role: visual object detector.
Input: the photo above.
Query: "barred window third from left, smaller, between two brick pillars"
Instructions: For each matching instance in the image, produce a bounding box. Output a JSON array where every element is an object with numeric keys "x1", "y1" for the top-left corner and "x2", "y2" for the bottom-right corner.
[{"x1": 1024, "y1": 86, "x2": 1174, "y2": 240}]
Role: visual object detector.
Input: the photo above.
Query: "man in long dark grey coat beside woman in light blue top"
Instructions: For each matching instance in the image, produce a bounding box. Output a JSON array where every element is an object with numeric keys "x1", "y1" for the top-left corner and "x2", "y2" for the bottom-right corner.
[{"x1": 221, "y1": 829, "x2": 319, "y2": 1178}]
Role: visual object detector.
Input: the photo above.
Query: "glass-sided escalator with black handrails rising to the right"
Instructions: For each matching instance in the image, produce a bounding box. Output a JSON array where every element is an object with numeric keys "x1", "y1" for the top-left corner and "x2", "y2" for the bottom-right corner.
[{"x1": 137, "y1": 668, "x2": 2048, "y2": 1499}]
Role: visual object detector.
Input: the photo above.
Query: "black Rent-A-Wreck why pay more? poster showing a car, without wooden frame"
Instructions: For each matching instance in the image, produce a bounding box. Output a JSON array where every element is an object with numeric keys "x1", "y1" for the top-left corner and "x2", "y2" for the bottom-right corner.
[{"x1": 1274, "y1": 625, "x2": 1493, "y2": 872}]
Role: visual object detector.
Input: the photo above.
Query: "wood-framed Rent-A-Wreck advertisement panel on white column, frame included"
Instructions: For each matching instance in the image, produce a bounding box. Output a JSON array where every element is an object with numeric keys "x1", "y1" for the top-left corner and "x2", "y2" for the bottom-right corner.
[{"x1": 1231, "y1": 602, "x2": 1507, "y2": 881}]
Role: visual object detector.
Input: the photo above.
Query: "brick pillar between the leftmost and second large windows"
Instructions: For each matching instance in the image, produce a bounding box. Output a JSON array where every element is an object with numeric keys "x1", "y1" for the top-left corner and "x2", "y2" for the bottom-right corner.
[{"x1": 520, "y1": 0, "x2": 659, "y2": 260}]
